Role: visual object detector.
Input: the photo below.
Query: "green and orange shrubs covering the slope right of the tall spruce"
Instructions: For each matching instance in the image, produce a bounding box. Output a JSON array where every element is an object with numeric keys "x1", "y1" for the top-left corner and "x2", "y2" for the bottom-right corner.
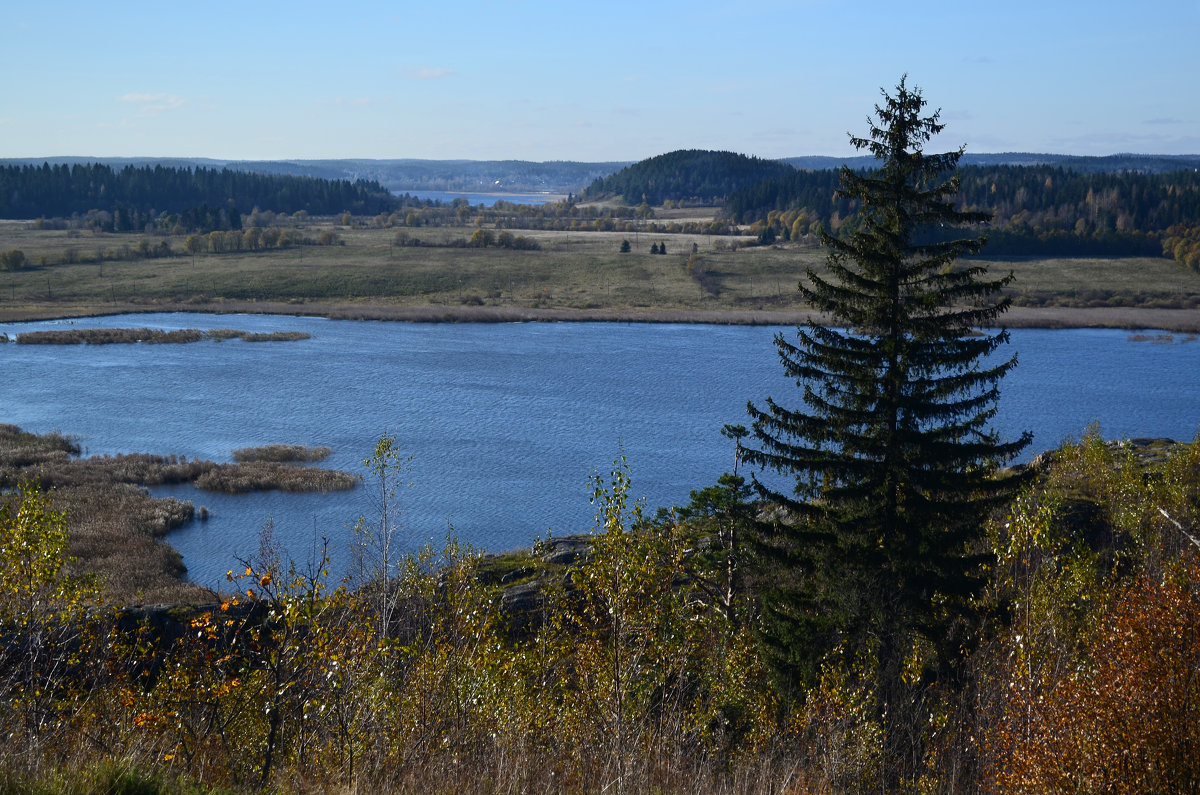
[{"x1": 977, "y1": 434, "x2": 1200, "y2": 793}]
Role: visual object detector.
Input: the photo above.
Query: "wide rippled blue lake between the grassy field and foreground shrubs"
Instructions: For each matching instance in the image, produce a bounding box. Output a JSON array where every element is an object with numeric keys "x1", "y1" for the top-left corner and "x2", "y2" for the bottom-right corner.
[{"x1": 0, "y1": 315, "x2": 1200, "y2": 585}]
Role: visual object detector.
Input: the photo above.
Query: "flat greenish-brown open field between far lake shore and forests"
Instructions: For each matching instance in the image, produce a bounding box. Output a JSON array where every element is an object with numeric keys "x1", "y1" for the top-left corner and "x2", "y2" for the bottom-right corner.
[{"x1": 0, "y1": 216, "x2": 1200, "y2": 330}]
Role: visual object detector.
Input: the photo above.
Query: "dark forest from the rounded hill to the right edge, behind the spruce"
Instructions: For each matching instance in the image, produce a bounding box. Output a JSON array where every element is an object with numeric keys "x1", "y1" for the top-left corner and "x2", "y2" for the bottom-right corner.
[{"x1": 582, "y1": 150, "x2": 1200, "y2": 269}]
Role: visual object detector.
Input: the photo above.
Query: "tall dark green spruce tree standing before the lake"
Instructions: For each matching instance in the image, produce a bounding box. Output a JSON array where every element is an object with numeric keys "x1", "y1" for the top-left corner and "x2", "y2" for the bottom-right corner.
[{"x1": 743, "y1": 79, "x2": 1031, "y2": 758}]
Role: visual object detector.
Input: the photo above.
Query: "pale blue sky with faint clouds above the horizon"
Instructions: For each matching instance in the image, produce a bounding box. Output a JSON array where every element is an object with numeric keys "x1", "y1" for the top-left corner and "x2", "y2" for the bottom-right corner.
[{"x1": 0, "y1": 0, "x2": 1200, "y2": 162}]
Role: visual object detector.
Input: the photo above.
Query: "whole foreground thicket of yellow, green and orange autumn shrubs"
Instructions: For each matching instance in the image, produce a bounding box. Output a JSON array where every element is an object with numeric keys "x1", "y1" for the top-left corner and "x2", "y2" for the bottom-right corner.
[{"x1": 0, "y1": 434, "x2": 1200, "y2": 793}]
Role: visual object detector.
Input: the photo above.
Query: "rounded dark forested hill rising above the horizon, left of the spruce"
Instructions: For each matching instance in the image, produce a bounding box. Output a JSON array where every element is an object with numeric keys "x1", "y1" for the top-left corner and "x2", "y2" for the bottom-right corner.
[{"x1": 582, "y1": 149, "x2": 796, "y2": 204}]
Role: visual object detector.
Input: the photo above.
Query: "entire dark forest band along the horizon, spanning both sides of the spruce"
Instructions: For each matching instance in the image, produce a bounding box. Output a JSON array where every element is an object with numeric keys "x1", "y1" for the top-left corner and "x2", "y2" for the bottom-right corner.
[{"x1": 7, "y1": 158, "x2": 1200, "y2": 270}]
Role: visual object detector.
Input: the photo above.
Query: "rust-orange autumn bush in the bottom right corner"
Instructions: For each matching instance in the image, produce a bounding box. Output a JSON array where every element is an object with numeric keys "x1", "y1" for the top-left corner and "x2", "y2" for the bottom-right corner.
[{"x1": 995, "y1": 551, "x2": 1200, "y2": 793}]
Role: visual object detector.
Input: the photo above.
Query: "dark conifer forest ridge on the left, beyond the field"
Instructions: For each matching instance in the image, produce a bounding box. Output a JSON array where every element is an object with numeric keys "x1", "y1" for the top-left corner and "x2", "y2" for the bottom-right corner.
[{"x1": 0, "y1": 163, "x2": 396, "y2": 219}]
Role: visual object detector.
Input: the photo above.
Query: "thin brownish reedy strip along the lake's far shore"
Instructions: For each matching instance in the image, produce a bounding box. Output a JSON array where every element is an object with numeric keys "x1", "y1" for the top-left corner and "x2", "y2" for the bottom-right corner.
[{"x1": 0, "y1": 301, "x2": 1200, "y2": 334}]
